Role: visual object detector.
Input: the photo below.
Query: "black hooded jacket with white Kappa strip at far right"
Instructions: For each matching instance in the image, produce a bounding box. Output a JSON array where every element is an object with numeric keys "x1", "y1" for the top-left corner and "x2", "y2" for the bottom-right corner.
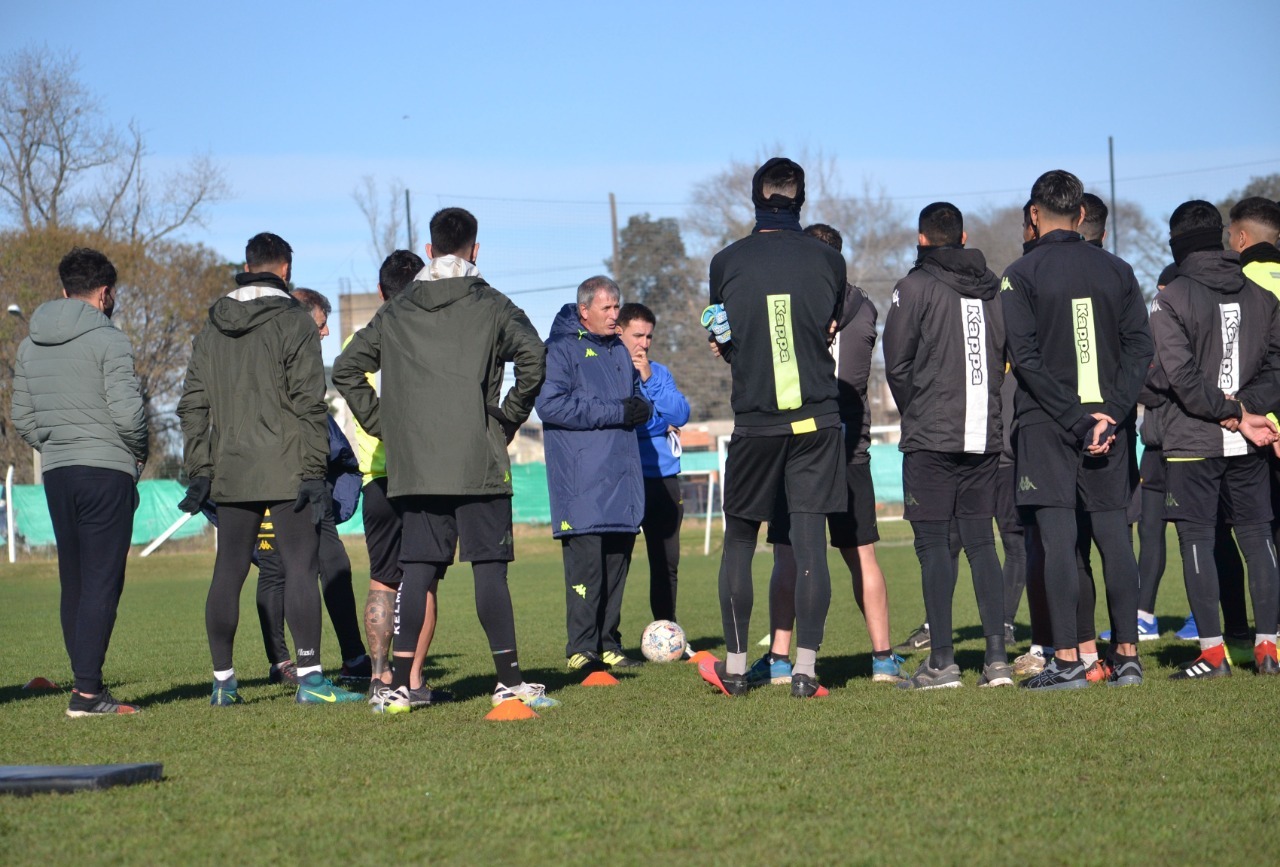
[{"x1": 1147, "y1": 250, "x2": 1280, "y2": 457}]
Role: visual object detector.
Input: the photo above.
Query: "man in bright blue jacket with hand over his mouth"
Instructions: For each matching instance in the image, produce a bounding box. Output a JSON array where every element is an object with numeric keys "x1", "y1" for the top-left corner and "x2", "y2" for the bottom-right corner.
[{"x1": 618, "y1": 304, "x2": 689, "y2": 621}]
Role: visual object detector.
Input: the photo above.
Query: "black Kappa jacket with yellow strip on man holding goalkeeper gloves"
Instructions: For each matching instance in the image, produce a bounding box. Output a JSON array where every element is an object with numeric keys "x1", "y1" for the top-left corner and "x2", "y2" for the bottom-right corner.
[{"x1": 710, "y1": 231, "x2": 845, "y2": 434}]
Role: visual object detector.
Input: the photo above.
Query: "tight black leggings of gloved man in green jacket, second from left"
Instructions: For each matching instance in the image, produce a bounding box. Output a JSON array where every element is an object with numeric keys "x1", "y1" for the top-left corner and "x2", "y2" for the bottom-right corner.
[{"x1": 205, "y1": 501, "x2": 320, "y2": 671}]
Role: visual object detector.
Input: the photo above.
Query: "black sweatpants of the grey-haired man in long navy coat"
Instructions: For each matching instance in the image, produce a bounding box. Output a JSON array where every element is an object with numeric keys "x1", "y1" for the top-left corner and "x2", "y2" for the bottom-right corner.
[{"x1": 561, "y1": 533, "x2": 636, "y2": 657}]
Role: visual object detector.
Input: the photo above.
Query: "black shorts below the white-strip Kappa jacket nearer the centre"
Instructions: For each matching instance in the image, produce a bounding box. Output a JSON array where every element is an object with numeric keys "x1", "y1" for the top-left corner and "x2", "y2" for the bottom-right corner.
[{"x1": 902, "y1": 452, "x2": 1000, "y2": 521}]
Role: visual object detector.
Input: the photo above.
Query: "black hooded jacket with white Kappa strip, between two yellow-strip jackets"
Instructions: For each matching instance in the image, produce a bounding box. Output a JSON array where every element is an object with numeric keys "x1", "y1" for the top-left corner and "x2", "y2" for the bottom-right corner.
[{"x1": 884, "y1": 247, "x2": 1005, "y2": 455}]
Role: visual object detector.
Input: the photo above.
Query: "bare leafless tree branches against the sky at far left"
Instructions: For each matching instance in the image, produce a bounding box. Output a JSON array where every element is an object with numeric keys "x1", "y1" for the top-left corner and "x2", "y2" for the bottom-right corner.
[{"x1": 0, "y1": 49, "x2": 229, "y2": 243}]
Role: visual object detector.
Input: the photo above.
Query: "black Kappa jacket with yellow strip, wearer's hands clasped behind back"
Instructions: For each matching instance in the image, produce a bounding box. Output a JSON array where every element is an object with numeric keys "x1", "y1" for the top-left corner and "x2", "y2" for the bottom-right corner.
[{"x1": 1000, "y1": 229, "x2": 1152, "y2": 439}]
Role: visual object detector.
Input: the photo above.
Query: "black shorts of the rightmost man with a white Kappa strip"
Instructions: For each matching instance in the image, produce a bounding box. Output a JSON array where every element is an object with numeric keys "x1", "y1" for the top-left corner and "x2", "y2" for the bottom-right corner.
[{"x1": 1165, "y1": 452, "x2": 1271, "y2": 525}]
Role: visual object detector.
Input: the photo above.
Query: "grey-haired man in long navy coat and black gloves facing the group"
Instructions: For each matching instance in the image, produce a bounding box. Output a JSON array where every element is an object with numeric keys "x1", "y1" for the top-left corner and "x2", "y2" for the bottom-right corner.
[{"x1": 536, "y1": 277, "x2": 653, "y2": 671}]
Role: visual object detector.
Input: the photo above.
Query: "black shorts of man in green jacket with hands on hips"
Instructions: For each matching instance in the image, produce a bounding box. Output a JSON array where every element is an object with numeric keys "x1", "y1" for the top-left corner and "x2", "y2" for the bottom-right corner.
[{"x1": 396, "y1": 496, "x2": 516, "y2": 563}]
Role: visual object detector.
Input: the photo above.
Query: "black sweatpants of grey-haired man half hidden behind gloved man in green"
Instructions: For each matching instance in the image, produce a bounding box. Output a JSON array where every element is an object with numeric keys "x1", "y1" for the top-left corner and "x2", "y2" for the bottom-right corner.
[{"x1": 257, "y1": 511, "x2": 365, "y2": 665}]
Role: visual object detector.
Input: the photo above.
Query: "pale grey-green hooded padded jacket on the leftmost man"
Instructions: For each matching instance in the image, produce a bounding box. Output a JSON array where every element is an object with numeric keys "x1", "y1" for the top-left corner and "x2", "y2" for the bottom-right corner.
[{"x1": 12, "y1": 298, "x2": 147, "y2": 479}]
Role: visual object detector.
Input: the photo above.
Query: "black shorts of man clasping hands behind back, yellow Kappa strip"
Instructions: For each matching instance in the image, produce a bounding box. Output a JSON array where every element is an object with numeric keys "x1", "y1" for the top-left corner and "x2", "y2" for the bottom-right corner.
[{"x1": 1014, "y1": 421, "x2": 1138, "y2": 512}]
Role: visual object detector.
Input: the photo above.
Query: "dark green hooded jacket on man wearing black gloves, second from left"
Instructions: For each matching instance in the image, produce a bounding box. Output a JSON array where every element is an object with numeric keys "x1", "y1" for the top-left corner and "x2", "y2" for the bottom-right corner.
[{"x1": 178, "y1": 293, "x2": 329, "y2": 503}]
